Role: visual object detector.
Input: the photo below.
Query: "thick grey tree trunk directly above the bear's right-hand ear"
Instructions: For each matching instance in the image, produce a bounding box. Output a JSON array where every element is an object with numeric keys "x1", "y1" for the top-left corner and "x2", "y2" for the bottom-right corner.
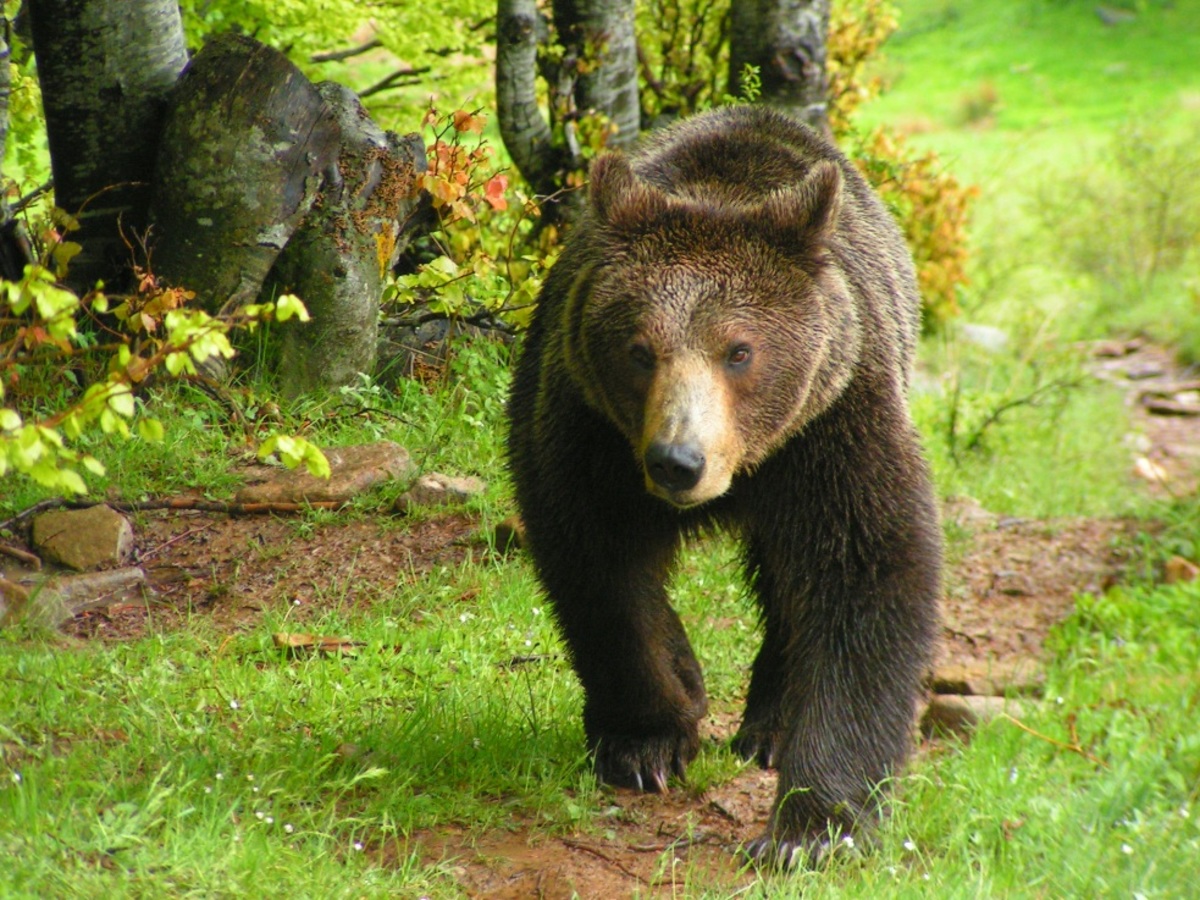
[{"x1": 730, "y1": 0, "x2": 829, "y2": 133}]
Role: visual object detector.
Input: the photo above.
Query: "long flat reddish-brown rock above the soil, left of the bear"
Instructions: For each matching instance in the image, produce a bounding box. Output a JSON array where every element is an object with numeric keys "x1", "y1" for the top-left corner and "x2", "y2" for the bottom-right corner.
[{"x1": 234, "y1": 440, "x2": 413, "y2": 503}]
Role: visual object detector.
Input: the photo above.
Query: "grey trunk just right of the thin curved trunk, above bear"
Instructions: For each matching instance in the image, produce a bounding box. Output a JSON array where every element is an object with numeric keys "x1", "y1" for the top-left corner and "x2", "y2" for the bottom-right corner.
[{"x1": 553, "y1": 0, "x2": 641, "y2": 146}]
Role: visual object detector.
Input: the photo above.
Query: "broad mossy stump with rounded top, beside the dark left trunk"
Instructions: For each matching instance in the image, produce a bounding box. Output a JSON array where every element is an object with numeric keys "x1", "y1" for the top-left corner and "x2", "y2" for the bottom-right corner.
[{"x1": 151, "y1": 34, "x2": 338, "y2": 312}]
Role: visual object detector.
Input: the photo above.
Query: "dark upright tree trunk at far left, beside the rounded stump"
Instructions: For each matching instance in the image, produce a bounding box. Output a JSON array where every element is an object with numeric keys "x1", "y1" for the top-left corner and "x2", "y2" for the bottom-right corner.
[{"x1": 28, "y1": 0, "x2": 187, "y2": 292}]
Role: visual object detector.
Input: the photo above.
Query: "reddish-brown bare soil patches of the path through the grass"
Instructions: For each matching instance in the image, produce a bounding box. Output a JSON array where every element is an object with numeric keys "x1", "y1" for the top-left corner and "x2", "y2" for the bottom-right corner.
[{"x1": 23, "y1": 343, "x2": 1200, "y2": 898}]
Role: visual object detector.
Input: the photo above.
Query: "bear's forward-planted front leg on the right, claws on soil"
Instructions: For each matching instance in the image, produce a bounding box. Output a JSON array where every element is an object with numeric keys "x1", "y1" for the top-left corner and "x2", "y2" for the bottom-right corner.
[{"x1": 734, "y1": 408, "x2": 941, "y2": 865}]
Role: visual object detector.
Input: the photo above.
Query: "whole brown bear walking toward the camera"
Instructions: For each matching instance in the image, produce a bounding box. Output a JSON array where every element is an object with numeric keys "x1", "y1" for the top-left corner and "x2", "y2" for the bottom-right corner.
[{"x1": 509, "y1": 106, "x2": 942, "y2": 866}]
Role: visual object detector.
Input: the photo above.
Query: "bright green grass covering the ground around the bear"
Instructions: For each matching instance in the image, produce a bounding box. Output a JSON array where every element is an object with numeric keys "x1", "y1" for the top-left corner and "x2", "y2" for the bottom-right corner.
[{"x1": 0, "y1": 0, "x2": 1200, "y2": 899}]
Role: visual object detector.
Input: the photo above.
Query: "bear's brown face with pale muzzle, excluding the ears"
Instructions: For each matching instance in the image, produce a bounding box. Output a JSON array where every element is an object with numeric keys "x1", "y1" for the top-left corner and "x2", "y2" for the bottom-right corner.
[{"x1": 568, "y1": 244, "x2": 838, "y2": 508}]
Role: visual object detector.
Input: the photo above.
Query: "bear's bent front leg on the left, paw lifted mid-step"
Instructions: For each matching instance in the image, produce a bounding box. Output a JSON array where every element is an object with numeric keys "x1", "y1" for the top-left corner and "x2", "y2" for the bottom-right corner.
[{"x1": 512, "y1": 413, "x2": 708, "y2": 791}]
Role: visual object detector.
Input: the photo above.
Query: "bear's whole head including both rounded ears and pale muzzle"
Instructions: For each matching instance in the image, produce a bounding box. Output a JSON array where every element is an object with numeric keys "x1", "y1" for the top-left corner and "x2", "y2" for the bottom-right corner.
[{"x1": 562, "y1": 154, "x2": 860, "y2": 508}]
